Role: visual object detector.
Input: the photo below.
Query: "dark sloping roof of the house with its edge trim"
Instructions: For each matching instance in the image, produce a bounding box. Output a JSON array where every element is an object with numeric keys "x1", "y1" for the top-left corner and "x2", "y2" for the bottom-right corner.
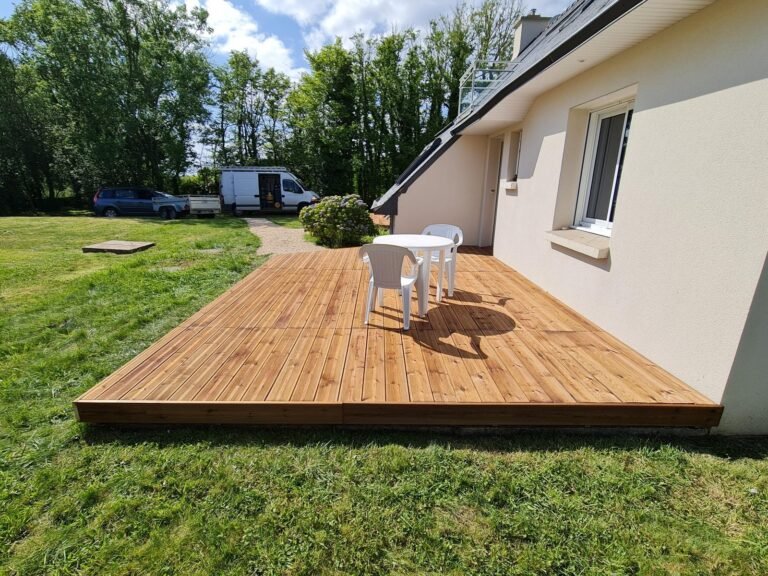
[{"x1": 372, "y1": 0, "x2": 645, "y2": 215}]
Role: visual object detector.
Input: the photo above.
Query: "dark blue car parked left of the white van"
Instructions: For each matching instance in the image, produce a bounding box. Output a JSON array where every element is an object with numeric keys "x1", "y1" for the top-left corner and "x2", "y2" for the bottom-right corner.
[{"x1": 93, "y1": 186, "x2": 189, "y2": 220}]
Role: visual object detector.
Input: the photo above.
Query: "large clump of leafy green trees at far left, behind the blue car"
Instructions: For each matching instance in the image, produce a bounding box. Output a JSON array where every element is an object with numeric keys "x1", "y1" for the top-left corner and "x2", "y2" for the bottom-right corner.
[{"x1": 0, "y1": 0, "x2": 209, "y2": 207}]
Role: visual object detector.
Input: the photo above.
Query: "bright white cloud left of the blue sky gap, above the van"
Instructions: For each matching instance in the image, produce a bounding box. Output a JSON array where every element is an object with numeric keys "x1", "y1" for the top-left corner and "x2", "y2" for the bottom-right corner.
[{"x1": 186, "y1": 0, "x2": 305, "y2": 80}]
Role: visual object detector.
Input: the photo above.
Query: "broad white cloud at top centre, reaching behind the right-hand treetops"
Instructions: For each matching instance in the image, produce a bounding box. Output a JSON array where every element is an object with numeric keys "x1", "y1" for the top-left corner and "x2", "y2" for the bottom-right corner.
[{"x1": 253, "y1": 0, "x2": 571, "y2": 50}]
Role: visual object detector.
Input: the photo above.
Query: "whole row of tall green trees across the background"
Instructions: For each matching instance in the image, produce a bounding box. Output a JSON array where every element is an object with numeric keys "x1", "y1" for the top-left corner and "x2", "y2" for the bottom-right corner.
[{"x1": 0, "y1": 0, "x2": 520, "y2": 214}]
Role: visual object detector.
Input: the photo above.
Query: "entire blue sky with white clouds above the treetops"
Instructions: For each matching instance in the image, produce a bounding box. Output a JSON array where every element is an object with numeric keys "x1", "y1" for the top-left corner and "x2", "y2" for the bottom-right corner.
[{"x1": 0, "y1": 0, "x2": 571, "y2": 80}]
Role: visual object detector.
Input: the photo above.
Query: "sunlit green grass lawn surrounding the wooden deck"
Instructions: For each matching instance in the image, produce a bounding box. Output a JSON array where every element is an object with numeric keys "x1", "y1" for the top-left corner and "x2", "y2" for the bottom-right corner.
[{"x1": 0, "y1": 217, "x2": 768, "y2": 576}]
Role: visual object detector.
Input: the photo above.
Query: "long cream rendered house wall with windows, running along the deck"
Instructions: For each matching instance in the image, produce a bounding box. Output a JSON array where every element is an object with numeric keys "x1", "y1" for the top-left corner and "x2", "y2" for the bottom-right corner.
[{"x1": 494, "y1": 0, "x2": 768, "y2": 433}]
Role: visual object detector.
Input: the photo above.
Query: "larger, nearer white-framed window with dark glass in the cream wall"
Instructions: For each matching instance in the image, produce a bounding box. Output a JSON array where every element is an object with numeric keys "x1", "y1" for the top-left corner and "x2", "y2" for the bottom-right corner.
[{"x1": 574, "y1": 102, "x2": 634, "y2": 236}]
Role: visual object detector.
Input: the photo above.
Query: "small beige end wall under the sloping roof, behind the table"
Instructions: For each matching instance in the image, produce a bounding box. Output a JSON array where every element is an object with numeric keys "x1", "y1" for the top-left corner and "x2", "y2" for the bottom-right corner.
[{"x1": 394, "y1": 136, "x2": 488, "y2": 246}]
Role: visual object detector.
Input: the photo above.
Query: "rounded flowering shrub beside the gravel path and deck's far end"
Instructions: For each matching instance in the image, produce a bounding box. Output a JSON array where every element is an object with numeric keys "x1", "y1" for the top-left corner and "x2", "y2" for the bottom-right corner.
[{"x1": 299, "y1": 194, "x2": 376, "y2": 248}]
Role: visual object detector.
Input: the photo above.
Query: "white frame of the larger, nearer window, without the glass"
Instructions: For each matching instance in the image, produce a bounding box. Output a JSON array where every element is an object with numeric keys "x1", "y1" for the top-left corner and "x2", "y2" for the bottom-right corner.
[{"x1": 573, "y1": 98, "x2": 635, "y2": 236}]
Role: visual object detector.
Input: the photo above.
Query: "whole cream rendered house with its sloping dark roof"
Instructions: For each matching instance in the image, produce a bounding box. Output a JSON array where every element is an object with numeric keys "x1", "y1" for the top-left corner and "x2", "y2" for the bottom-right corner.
[{"x1": 374, "y1": 0, "x2": 768, "y2": 434}]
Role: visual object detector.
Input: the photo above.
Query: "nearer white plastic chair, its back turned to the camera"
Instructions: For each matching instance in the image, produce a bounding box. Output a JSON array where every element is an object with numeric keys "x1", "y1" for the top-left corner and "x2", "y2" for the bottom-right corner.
[{"x1": 360, "y1": 244, "x2": 423, "y2": 330}]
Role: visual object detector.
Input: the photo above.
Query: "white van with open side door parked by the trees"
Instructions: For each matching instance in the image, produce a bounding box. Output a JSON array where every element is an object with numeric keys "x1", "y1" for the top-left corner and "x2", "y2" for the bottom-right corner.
[{"x1": 219, "y1": 166, "x2": 320, "y2": 215}]
